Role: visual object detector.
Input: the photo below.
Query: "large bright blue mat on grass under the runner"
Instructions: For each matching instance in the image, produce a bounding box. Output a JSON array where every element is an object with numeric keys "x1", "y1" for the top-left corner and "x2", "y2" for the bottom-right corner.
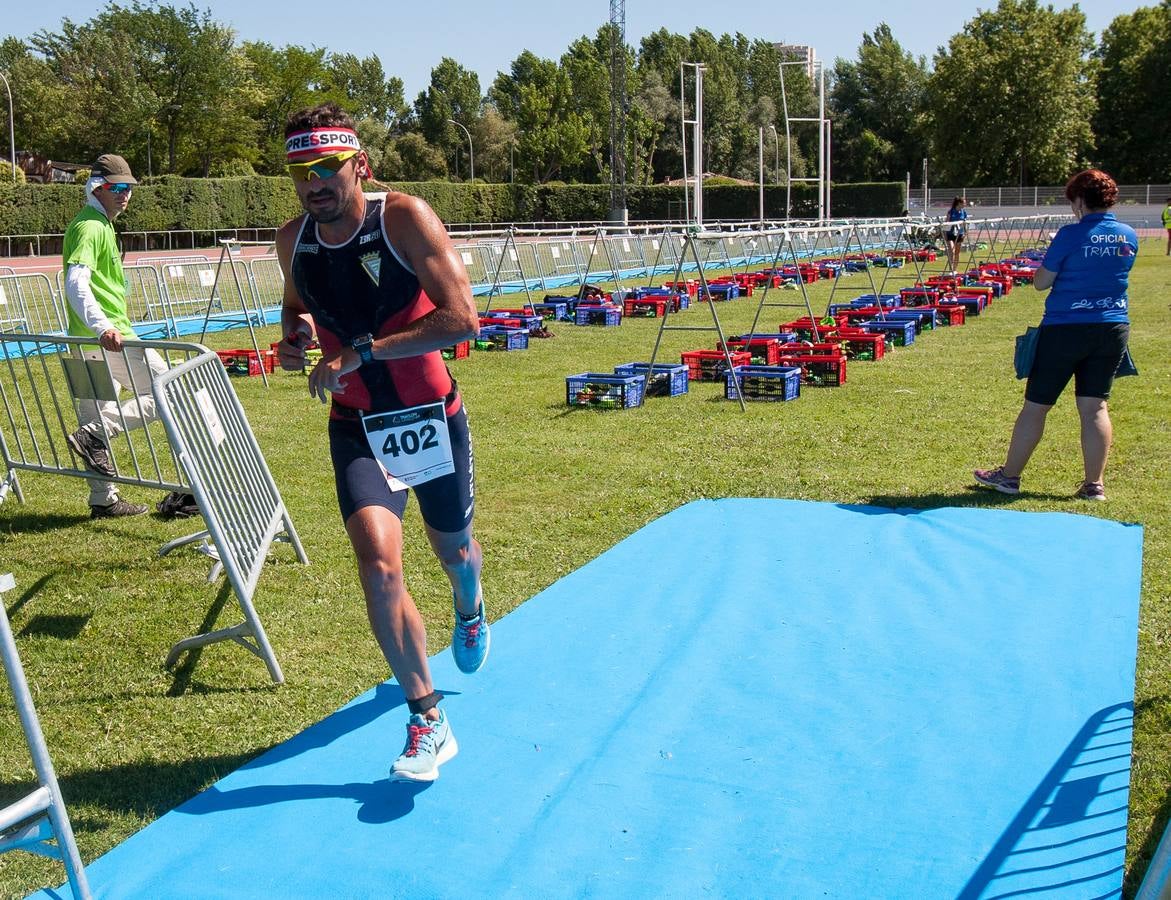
[{"x1": 42, "y1": 500, "x2": 1142, "y2": 899}]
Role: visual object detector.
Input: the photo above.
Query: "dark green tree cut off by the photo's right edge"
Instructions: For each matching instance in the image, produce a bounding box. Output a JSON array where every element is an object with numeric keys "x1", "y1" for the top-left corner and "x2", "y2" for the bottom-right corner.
[{"x1": 1094, "y1": 0, "x2": 1171, "y2": 181}]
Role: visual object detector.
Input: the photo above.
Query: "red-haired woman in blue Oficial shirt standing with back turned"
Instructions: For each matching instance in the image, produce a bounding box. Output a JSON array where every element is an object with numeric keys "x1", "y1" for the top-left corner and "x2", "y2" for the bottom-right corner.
[{"x1": 973, "y1": 169, "x2": 1138, "y2": 500}]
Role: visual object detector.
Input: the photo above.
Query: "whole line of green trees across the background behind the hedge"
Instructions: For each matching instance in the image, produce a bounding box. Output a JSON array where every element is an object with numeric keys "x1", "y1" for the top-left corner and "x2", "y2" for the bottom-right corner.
[{"x1": 0, "y1": 0, "x2": 1171, "y2": 186}]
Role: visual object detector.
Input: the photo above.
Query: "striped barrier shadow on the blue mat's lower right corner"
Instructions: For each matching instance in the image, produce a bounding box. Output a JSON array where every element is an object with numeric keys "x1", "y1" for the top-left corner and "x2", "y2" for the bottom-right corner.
[{"x1": 957, "y1": 703, "x2": 1135, "y2": 900}]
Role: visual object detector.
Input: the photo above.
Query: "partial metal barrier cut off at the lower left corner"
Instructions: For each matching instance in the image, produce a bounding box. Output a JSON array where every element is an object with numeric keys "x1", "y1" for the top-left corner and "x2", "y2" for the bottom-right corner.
[{"x1": 0, "y1": 575, "x2": 90, "y2": 900}]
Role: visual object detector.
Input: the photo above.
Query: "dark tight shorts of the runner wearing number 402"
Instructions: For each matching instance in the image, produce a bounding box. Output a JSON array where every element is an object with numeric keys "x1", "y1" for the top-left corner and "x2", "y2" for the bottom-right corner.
[{"x1": 329, "y1": 403, "x2": 475, "y2": 533}]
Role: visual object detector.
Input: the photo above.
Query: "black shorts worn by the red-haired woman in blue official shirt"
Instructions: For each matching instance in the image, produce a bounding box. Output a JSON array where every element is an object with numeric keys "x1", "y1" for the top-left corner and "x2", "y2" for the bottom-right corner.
[{"x1": 1025, "y1": 322, "x2": 1130, "y2": 406}]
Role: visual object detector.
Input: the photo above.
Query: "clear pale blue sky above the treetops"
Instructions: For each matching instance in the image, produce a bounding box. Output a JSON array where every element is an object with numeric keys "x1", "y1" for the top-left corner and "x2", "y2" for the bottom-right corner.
[{"x1": 0, "y1": 0, "x2": 1157, "y2": 102}]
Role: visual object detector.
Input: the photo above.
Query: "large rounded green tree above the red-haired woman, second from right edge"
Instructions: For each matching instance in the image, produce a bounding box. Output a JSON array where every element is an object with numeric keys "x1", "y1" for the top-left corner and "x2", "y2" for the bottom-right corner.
[{"x1": 926, "y1": 0, "x2": 1095, "y2": 185}]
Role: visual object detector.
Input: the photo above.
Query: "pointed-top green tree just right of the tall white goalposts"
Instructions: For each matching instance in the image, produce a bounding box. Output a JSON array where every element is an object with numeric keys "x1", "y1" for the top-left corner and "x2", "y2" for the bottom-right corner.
[{"x1": 830, "y1": 22, "x2": 927, "y2": 181}]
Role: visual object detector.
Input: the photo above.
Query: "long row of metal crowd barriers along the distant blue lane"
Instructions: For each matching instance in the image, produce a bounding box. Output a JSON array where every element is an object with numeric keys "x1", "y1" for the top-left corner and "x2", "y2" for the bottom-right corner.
[{"x1": 0, "y1": 215, "x2": 1068, "y2": 338}]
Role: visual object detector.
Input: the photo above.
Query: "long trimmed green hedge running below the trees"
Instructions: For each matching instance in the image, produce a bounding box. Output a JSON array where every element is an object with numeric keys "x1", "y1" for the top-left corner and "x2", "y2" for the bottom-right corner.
[{"x1": 0, "y1": 176, "x2": 906, "y2": 235}]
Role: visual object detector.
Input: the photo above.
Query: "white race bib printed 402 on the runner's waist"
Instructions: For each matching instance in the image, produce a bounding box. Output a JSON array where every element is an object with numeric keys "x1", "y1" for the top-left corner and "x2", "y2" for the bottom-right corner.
[{"x1": 362, "y1": 400, "x2": 456, "y2": 490}]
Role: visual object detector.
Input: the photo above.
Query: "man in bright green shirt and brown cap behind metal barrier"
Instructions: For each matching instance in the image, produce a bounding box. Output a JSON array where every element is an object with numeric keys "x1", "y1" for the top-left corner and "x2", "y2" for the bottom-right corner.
[{"x1": 61, "y1": 153, "x2": 166, "y2": 518}]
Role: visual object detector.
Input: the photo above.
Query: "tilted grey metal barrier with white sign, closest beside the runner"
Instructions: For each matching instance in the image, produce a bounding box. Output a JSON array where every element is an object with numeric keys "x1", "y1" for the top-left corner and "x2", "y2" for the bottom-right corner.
[{"x1": 155, "y1": 352, "x2": 309, "y2": 683}]
